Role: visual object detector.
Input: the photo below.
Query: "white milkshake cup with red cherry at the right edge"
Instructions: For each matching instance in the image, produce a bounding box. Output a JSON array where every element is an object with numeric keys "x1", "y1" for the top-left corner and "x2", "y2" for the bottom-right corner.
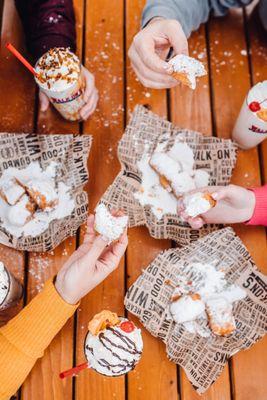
[{"x1": 232, "y1": 81, "x2": 267, "y2": 149}]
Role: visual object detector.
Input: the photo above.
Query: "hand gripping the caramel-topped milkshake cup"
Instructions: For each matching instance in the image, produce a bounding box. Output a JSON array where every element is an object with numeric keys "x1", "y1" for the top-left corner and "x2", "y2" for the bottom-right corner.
[{"x1": 39, "y1": 66, "x2": 98, "y2": 120}]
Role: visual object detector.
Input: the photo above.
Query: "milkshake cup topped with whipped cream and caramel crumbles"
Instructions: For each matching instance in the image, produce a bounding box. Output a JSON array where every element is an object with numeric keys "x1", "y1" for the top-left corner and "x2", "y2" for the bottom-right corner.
[{"x1": 35, "y1": 47, "x2": 85, "y2": 121}]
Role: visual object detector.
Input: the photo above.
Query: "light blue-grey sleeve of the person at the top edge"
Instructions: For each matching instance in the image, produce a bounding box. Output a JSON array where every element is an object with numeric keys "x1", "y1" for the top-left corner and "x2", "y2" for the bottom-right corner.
[{"x1": 142, "y1": 0, "x2": 252, "y2": 37}]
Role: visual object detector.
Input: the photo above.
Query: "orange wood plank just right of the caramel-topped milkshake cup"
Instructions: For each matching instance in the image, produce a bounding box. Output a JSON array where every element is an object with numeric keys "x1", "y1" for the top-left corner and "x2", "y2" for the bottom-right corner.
[{"x1": 76, "y1": 0, "x2": 125, "y2": 400}]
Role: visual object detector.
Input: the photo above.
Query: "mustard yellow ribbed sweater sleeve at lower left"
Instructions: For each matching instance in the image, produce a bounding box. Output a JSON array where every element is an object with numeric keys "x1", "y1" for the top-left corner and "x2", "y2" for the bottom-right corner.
[{"x1": 0, "y1": 280, "x2": 78, "y2": 400}]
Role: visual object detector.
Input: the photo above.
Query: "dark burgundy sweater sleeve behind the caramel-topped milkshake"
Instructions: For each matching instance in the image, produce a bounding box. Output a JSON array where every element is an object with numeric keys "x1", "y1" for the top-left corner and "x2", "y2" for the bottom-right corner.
[{"x1": 15, "y1": 0, "x2": 76, "y2": 61}]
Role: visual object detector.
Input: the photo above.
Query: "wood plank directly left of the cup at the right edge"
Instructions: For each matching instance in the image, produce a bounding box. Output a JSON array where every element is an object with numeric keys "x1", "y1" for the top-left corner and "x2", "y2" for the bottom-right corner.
[{"x1": 210, "y1": 10, "x2": 267, "y2": 400}]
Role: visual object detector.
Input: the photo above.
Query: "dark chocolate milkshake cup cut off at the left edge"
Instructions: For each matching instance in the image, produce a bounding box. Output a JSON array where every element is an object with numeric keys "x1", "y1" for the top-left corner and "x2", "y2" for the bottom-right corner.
[{"x1": 0, "y1": 262, "x2": 23, "y2": 311}]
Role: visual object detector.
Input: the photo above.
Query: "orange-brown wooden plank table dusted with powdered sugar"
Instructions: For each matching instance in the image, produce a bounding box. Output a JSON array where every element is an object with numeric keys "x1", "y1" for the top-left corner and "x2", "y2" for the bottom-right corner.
[{"x1": 0, "y1": 0, "x2": 267, "y2": 400}]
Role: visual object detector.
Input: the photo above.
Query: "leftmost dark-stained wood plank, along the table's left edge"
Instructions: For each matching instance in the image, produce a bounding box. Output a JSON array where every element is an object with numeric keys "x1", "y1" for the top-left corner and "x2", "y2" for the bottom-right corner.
[{"x1": 0, "y1": 0, "x2": 35, "y2": 323}]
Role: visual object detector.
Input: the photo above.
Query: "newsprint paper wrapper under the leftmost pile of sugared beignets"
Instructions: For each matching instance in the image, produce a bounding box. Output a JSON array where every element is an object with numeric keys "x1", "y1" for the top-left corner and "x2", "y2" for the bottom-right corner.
[{"x1": 0, "y1": 133, "x2": 92, "y2": 252}]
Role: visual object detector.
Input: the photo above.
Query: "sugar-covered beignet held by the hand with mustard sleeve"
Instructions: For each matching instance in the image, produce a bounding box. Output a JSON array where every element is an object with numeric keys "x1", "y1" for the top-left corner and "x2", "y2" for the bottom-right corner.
[{"x1": 95, "y1": 203, "x2": 128, "y2": 242}]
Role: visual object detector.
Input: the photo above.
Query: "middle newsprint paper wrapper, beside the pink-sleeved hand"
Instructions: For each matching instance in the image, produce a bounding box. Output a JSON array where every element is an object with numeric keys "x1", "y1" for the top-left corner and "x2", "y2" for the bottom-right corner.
[{"x1": 101, "y1": 106, "x2": 237, "y2": 245}]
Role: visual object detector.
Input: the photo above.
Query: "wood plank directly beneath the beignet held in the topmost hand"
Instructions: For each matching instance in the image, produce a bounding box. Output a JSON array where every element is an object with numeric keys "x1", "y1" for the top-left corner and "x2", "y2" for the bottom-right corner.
[{"x1": 171, "y1": 26, "x2": 230, "y2": 400}]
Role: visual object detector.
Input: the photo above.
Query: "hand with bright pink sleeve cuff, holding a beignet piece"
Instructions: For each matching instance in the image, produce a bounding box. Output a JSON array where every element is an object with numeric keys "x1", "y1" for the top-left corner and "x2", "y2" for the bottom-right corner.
[{"x1": 178, "y1": 185, "x2": 256, "y2": 229}]
